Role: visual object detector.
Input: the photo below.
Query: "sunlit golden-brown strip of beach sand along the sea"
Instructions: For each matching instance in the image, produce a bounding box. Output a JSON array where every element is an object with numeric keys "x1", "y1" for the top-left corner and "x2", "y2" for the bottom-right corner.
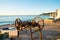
[{"x1": 0, "y1": 23, "x2": 60, "y2": 31}]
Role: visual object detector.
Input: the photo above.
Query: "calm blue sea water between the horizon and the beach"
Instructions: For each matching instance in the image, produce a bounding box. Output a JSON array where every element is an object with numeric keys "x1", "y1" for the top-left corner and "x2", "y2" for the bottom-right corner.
[{"x1": 0, "y1": 15, "x2": 49, "y2": 25}]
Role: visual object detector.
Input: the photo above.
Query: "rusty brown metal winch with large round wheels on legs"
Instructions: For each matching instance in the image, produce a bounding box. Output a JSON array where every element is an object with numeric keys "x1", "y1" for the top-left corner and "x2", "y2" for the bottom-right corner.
[{"x1": 15, "y1": 17, "x2": 44, "y2": 40}]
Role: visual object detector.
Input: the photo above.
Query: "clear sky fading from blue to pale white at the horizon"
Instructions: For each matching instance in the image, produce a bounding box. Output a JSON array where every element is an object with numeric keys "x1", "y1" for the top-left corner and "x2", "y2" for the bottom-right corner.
[{"x1": 0, "y1": 0, "x2": 60, "y2": 15}]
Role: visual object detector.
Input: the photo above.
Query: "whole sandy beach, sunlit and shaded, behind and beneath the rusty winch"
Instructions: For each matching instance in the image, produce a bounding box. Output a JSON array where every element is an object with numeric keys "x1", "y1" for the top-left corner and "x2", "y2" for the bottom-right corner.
[{"x1": 0, "y1": 22, "x2": 60, "y2": 40}]
